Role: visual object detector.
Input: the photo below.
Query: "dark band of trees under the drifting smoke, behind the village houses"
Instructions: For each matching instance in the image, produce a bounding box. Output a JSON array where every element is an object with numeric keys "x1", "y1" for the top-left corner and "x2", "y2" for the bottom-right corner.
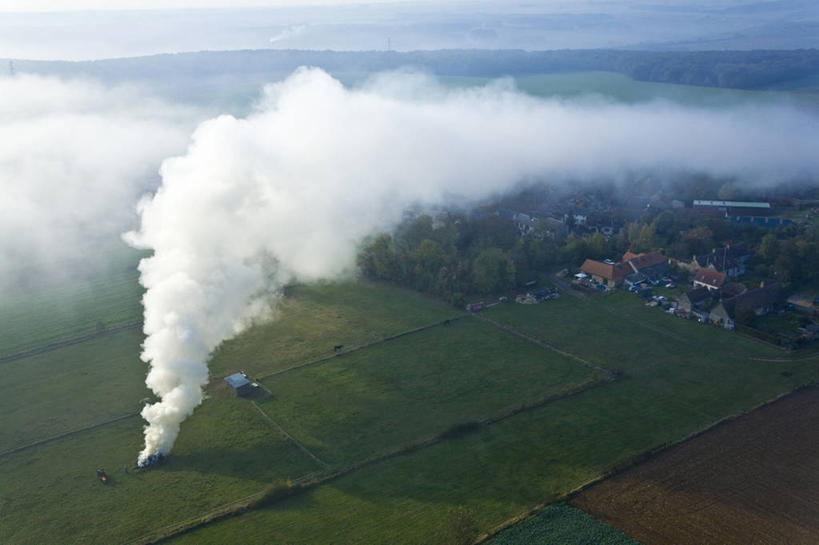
[{"x1": 358, "y1": 199, "x2": 819, "y2": 305}]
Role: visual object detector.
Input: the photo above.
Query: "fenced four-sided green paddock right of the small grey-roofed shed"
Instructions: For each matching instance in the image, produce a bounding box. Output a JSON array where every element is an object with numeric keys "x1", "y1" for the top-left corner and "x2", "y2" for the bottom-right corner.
[{"x1": 255, "y1": 318, "x2": 599, "y2": 463}]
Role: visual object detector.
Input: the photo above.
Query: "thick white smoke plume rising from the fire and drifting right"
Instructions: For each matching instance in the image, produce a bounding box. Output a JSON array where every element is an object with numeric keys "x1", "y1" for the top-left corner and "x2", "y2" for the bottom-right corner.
[{"x1": 127, "y1": 69, "x2": 819, "y2": 461}]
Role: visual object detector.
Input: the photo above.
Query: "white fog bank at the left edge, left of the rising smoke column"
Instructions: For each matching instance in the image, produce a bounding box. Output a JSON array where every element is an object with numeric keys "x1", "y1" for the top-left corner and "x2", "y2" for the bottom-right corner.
[{"x1": 0, "y1": 75, "x2": 195, "y2": 287}]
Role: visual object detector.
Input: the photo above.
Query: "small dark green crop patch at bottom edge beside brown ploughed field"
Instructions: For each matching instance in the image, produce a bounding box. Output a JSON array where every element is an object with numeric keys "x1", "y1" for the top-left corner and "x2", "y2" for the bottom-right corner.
[{"x1": 489, "y1": 503, "x2": 640, "y2": 545}]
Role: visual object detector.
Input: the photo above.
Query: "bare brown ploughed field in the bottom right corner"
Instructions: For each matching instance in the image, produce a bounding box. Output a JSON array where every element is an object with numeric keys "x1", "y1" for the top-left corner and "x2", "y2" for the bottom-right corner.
[{"x1": 573, "y1": 388, "x2": 819, "y2": 545}]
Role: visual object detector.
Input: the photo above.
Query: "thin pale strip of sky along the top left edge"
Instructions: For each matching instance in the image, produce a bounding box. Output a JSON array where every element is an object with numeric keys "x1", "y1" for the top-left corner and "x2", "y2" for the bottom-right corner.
[{"x1": 0, "y1": 0, "x2": 422, "y2": 11}]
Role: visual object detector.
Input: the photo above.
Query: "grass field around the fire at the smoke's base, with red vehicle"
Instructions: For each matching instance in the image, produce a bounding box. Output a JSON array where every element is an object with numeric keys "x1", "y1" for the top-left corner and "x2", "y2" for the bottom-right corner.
[{"x1": 0, "y1": 397, "x2": 316, "y2": 545}]
